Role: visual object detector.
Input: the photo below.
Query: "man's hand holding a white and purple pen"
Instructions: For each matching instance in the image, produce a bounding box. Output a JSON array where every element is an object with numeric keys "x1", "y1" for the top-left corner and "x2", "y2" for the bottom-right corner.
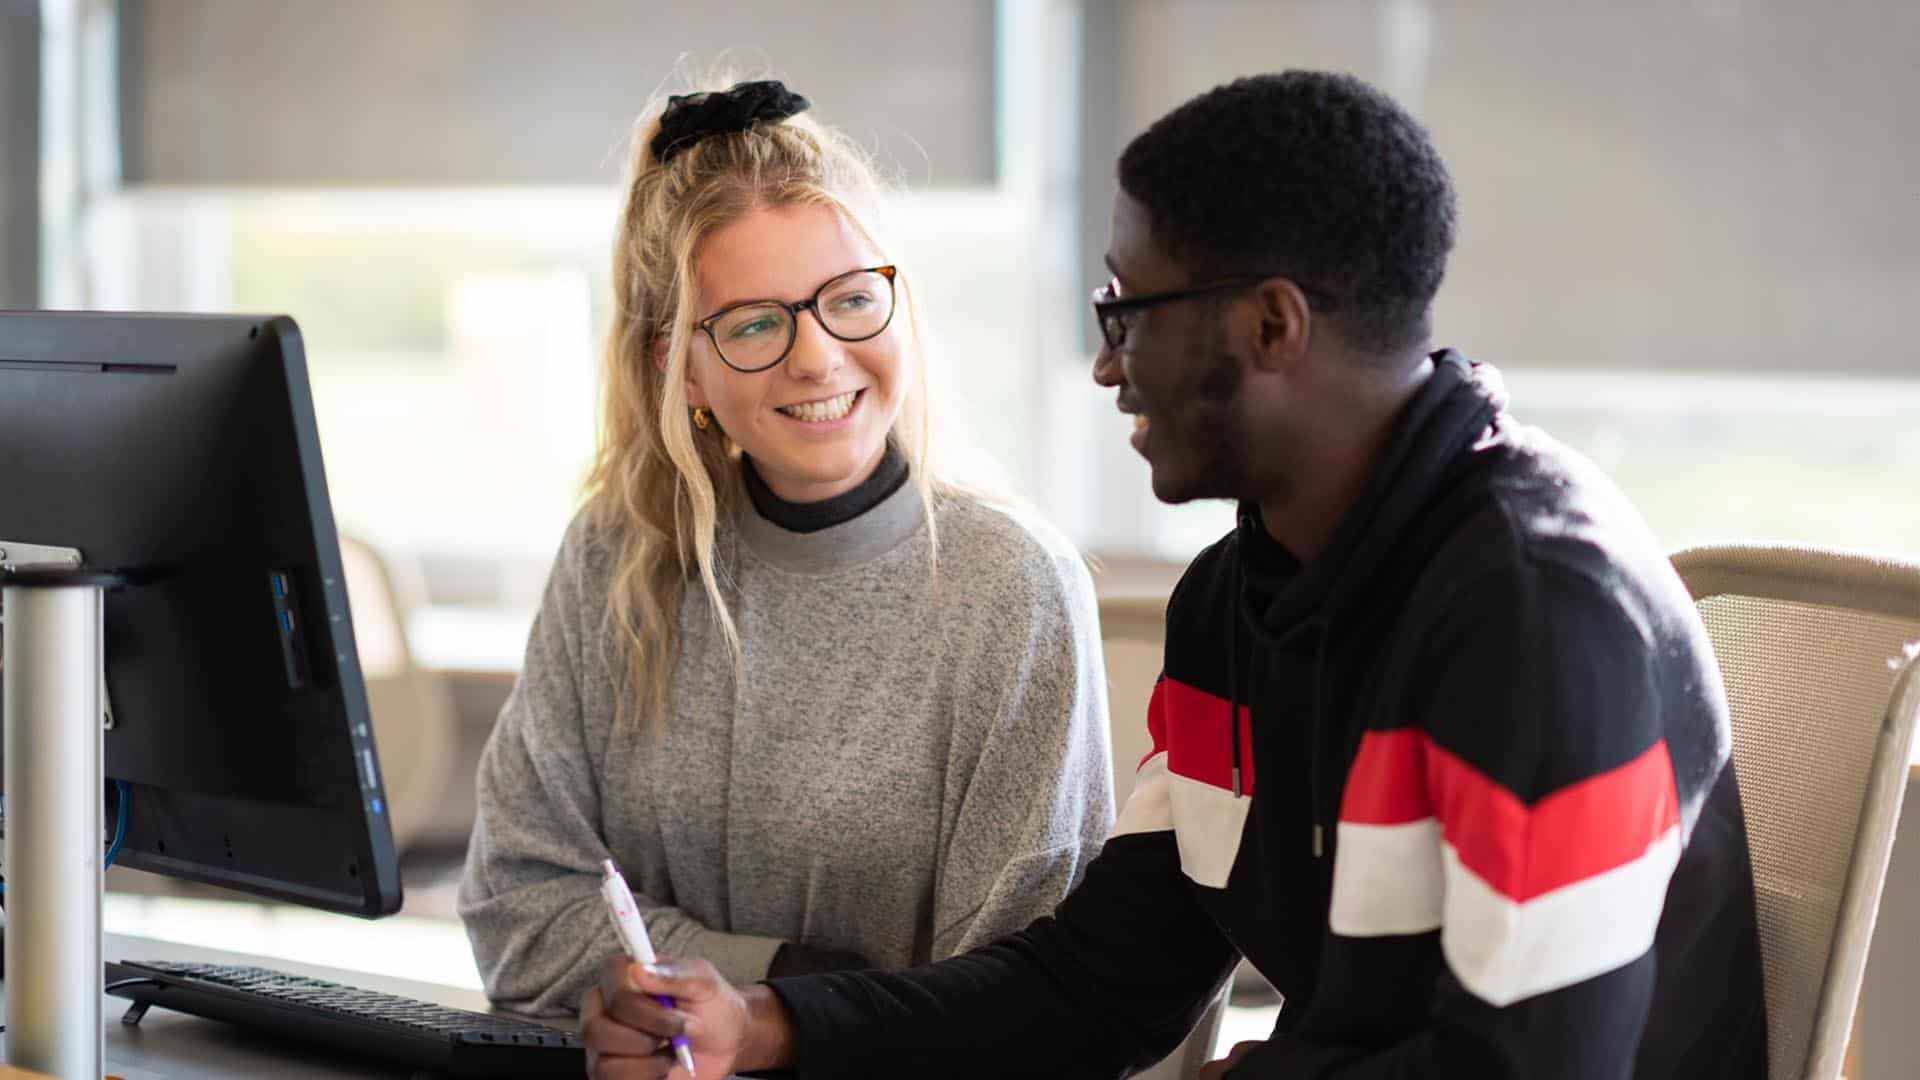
[{"x1": 580, "y1": 957, "x2": 751, "y2": 1080}]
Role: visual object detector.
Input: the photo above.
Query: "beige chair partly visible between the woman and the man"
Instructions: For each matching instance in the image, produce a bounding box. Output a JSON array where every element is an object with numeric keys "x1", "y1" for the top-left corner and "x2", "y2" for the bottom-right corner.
[{"x1": 1100, "y1": 590, "x2": 1236, "y2": 1080}]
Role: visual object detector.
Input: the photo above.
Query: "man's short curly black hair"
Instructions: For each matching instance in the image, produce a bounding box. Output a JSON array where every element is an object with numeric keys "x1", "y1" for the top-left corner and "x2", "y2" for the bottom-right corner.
[{"x1": 1119, "y1": 71, "x2": 1453, "y2": 356}]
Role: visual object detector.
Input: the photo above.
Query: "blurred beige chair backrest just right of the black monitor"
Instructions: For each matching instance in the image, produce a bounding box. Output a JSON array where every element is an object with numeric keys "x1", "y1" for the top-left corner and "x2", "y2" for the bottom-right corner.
[{"x1": 340, "y1": 534, "x2": 455, "y2": 853}]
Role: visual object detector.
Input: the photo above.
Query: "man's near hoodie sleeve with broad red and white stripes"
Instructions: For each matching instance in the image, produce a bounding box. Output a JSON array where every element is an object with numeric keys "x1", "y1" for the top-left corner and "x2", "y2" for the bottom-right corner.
[{"x1": 1229, "y1": 561, "x2": 1682, "y2": 1080}]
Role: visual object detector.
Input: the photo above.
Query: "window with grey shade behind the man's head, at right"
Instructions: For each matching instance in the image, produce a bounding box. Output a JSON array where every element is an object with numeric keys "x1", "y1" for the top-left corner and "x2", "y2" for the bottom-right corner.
[{"x1": 1081, "y1": 0, "x2": 1920, "y2": 557}]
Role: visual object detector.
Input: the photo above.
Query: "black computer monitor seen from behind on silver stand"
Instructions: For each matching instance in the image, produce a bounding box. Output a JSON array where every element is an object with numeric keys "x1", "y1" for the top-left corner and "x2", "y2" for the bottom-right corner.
[{"x1": 0, "y1": 311, "x2": 401, "y2": 917}]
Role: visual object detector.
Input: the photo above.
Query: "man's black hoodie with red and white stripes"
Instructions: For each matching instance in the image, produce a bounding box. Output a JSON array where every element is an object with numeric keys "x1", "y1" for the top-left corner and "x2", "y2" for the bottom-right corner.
[{"x1": 772, "y1": 352, "x2": 1766, "y2": 1080}]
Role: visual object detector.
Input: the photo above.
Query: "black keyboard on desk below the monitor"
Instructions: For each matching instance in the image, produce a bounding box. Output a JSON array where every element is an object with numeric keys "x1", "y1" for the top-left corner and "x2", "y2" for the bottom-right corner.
[{"x1": 106, "y1": 961, "x2": 588, "y2": 1078}]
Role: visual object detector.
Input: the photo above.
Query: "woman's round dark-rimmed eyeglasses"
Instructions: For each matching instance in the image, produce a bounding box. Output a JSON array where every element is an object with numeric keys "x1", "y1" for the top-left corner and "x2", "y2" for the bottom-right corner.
[{"x1": 695, "y1": 267, "x2": 899, "y2": 375}]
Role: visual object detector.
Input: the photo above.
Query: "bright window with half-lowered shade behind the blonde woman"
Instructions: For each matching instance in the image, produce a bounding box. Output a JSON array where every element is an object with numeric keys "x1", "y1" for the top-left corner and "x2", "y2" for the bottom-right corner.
[{"x1": 84, "y1": 0, "x2": 1029, "y2": 609}]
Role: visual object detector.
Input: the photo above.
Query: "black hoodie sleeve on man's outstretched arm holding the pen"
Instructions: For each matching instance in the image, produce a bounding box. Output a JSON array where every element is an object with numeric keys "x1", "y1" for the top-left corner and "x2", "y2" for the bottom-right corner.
[{"x1": 770, "y1": 641, "x2": 1238, "y2": 1080}]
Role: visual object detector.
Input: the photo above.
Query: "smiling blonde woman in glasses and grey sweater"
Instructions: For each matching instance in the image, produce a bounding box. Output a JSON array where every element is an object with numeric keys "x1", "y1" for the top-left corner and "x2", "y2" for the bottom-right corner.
[{"x1": 461, "y1": 83, "x2": 1112, "y2": 1011}]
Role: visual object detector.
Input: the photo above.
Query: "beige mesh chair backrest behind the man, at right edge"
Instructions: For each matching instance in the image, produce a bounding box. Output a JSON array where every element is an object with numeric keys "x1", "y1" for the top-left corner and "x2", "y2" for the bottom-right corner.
[{"x1": 1672, "y1": 546, "x2": 1920, "y2": 1080}]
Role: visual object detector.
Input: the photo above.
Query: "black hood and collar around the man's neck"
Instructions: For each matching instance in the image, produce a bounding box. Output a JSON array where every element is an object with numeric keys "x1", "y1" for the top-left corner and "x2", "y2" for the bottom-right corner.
[{"x1": 1236, "y1": 350, "x2": 1507, "y2": 646}]
